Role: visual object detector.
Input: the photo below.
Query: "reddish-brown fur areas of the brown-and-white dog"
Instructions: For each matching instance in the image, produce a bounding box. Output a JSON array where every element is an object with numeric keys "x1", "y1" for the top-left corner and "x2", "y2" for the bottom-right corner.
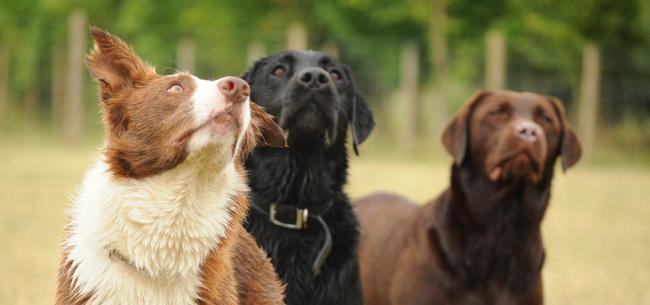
[{"x1": 56, "y1": 28, "x2": 286, "y2": 305}]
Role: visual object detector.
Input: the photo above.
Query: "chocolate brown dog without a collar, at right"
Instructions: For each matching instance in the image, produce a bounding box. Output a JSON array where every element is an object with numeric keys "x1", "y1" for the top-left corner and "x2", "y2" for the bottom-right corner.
[{"x1": 356, "y1": 91, "x2": 581, "y2": 305}]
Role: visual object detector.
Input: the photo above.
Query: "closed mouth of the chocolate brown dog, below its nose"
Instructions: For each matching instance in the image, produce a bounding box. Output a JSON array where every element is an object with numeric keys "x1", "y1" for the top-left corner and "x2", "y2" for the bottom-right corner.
[{"x1": 486, "y1": 146, "x2": 544, "y2": 183}]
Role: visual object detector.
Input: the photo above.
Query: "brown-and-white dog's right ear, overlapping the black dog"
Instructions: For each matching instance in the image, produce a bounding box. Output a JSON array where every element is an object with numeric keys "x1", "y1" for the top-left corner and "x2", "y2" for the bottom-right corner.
[{"x1": 250, "y1": 101, "x2": 287, "y2": 148}]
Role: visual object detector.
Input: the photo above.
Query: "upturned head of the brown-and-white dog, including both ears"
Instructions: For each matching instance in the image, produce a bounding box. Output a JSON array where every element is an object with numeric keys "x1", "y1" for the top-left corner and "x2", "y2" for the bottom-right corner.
[{"x1": 86, "y1": 28, "x2": 286, "y2": 178}]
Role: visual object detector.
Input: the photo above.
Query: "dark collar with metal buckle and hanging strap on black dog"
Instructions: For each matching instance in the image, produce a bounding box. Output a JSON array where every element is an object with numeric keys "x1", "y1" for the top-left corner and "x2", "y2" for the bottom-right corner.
[{"x1": 251, "y1": 200, "x2": 332, "y2": 276}]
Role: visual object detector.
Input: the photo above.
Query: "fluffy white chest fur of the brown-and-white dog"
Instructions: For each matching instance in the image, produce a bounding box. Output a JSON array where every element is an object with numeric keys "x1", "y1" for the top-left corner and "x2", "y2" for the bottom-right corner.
[{"x1": 65, "y1": 151, "x2": 246, "y2": 305}]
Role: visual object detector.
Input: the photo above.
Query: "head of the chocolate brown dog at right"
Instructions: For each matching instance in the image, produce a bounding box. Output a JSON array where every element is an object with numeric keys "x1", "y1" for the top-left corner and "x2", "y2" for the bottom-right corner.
[{"x1": 442, "y1": 91, "x2": 582, "y2": 183}]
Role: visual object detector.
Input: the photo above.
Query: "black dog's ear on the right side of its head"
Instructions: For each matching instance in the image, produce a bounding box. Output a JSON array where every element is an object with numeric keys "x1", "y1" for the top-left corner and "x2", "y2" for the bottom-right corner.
[{"x1": 343, "y1": 66, "x2": 375, "y2": 156}]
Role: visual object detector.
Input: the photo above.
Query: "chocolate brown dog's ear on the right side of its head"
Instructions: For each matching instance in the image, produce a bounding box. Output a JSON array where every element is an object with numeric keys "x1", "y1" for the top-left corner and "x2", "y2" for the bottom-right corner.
[{"x1": 548, "y1": 97, "x2": 582, "y2": 171}]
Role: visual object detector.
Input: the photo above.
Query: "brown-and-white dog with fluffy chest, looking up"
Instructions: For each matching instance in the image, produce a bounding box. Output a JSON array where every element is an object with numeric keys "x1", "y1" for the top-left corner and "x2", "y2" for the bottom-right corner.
[{"x1": 56, "y1": 28, "x2": 286, "y2": 305}]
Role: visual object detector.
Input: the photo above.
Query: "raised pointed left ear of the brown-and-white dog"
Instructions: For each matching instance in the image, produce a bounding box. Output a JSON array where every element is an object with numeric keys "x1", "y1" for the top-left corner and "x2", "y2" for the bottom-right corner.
[{"x1": 86, "y1": 27, "x2": 156, "y2": 101}]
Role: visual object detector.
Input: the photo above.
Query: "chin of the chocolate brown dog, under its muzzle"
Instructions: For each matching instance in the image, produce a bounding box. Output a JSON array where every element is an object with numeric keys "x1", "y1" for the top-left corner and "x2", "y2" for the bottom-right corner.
[{"x1": 486, "y1": 151, "x2": 543, "y2": 184}]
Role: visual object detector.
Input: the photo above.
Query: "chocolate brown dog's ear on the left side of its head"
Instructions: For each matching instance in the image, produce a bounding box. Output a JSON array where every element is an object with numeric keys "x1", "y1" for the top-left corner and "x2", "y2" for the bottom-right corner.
[{"x1": 442, "y1": 91, "x2": 491, "y2": 165}]
